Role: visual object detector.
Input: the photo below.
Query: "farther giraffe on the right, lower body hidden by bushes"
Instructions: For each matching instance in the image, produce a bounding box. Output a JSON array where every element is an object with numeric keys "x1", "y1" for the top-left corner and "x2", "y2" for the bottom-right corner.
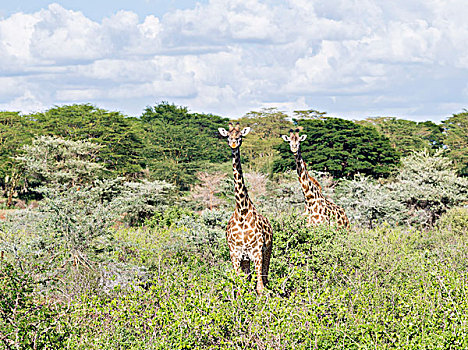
[{"x1": 281, "y1": 129, "x2": 349, "y2": 228}]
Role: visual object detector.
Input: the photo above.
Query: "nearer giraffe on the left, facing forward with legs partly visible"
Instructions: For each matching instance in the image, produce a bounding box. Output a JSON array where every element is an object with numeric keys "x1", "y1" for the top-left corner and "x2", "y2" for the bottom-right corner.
[{"x1": 218, "y1": 123, "x2": 273, "y2": 295}]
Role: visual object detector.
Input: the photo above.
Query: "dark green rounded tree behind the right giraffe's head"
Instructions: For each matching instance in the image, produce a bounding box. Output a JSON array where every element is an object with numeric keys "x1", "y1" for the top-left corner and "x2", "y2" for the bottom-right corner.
[{"x1": 273, "y1": 118, "x2": 399, "y2": 178}]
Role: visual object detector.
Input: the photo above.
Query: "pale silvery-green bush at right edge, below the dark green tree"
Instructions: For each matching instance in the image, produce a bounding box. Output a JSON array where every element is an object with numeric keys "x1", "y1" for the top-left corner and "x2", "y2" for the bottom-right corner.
[{"x1": 335, "y1": 150, "x2": 468, "y2": 227}]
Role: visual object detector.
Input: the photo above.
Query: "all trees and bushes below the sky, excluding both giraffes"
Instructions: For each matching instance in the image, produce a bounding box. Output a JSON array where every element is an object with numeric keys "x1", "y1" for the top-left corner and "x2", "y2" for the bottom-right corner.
[{"x1": 0, "y1": 102, "x2": 468, "y2": 349}]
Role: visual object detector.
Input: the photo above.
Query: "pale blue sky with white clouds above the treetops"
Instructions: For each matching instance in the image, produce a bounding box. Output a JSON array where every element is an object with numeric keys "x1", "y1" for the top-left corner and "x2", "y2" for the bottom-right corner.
[{"x1": 0, "y1": 0, "x2": 468, "y2": 121}]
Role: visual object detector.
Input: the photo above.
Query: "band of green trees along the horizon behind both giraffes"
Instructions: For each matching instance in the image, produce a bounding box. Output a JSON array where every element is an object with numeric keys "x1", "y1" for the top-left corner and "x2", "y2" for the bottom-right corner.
[{"x1": 0, "y1": 102, "x2": 468, "y2": 204}]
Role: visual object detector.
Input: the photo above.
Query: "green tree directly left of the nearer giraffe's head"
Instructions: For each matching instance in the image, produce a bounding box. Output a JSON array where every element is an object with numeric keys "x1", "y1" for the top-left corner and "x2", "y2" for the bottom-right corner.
[{"x1": 141, "y1": 102, "x2": 229, "y2": 189}]
